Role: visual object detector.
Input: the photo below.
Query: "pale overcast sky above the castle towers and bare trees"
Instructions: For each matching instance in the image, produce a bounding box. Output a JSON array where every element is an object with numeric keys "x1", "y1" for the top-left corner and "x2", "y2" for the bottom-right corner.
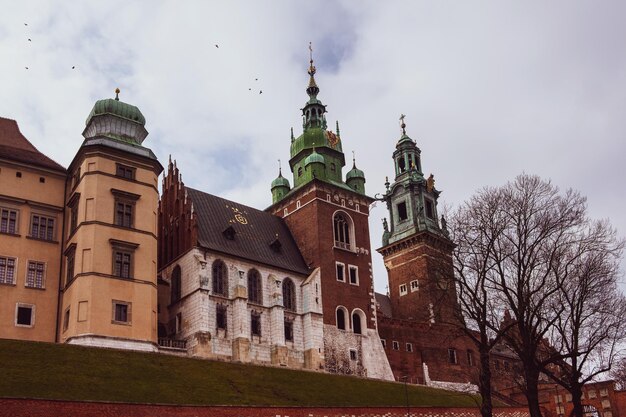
[{"x1": 0, "y1": 0, "x2": 626, "y2": 292}]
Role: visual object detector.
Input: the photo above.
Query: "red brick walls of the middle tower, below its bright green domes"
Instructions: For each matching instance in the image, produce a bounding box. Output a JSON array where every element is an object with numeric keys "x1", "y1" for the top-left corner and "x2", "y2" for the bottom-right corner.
[{"x1": 271, "y1": 182, "x2": 374, "y2": 328}]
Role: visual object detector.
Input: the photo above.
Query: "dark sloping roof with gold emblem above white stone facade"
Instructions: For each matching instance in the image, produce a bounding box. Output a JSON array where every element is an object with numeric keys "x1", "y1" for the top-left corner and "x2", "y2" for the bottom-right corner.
[{"x1": 185, "y1": 187, "x2": 310, "y2": 274}]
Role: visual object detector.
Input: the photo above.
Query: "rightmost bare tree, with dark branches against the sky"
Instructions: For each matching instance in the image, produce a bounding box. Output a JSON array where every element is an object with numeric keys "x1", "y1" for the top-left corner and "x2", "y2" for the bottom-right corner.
[{"x1": 537, "y1": 221, "x2": 626, "y2": 417}]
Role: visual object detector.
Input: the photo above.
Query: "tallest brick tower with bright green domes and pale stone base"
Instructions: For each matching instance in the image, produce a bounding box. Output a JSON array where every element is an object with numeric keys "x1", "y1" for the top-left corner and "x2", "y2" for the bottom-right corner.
[{"x1": 267, "y1": 47, "x2": 391, "y2": 378}]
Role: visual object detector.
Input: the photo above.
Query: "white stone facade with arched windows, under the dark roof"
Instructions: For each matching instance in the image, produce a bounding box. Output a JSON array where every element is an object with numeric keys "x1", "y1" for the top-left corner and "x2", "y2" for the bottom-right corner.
[{"x1": 161, "y1": 248, "x2": 324, "y2": 369}]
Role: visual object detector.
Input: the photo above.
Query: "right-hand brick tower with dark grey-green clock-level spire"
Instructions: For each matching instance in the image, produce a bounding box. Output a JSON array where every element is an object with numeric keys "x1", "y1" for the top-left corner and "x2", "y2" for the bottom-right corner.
[{"x1": 378, "y1": 116, "x2": 458, "y2": 323}]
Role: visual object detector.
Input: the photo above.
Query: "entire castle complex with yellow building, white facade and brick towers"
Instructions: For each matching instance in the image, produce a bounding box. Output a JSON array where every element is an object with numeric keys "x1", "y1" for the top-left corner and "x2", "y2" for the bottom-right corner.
[{"x1": 0, "y1": 60, "x2": 514, "y2": 388}]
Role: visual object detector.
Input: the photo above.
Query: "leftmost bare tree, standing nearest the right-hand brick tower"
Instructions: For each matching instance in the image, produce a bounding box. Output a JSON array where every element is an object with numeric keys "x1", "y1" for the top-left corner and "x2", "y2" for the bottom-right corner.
[{"x1": 450, "y1": 188, "x2": 506, "y2": 417}]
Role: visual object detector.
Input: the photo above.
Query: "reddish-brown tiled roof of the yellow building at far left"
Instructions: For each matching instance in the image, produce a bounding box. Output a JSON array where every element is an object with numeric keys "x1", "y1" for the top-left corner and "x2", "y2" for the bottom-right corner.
[{"x1": 0, "y1": 117, "x2": 65, "y2": 172}]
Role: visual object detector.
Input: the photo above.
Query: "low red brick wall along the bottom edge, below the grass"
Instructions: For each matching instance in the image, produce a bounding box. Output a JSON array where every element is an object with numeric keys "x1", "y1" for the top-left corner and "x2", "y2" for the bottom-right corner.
[{"x1": 0, "y1": 399, "x2": 529, "y2": 417}]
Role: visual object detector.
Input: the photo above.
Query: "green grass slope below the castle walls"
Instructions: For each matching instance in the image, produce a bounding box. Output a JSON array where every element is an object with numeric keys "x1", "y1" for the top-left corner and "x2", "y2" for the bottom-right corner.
[{"x1": 0, "y1": 339, "x2": 477, "y2": 407}]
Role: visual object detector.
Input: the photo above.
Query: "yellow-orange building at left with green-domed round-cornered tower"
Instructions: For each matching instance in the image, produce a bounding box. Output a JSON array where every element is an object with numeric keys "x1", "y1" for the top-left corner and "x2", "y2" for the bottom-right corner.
[{"x1": 0, "y1": 92, "x2": 163, "y2": 351}]
